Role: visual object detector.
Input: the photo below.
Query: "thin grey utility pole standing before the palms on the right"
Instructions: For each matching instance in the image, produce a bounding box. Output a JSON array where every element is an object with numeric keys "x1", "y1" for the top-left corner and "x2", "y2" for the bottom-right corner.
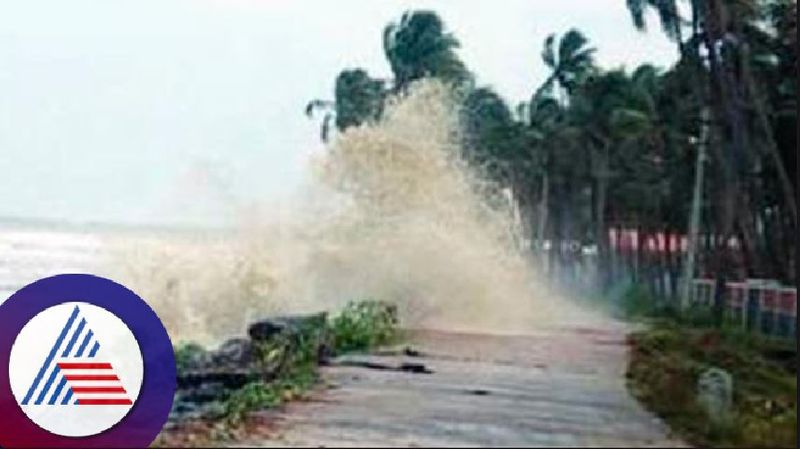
[{"x1": 680, "y1": 106, "x2": 709, "y2": 310}]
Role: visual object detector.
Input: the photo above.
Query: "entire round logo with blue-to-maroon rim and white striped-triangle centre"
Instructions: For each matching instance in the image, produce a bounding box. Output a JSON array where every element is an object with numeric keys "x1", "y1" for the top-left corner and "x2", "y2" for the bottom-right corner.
[{"x1": 0, "y1": 275, "x2": 176, "y2": 447}]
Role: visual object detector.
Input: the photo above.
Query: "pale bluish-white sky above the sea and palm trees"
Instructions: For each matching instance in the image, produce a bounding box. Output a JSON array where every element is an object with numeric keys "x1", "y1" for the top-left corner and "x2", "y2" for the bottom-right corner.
[{"x1": 0, "y1": 0, "x2": 676, "y2": 226}]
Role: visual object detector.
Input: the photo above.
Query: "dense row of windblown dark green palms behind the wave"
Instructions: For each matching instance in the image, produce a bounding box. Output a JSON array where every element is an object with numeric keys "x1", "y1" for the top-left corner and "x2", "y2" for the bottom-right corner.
[{"x1": 310, "y1": 0, "x2": 797, "y2": 286}]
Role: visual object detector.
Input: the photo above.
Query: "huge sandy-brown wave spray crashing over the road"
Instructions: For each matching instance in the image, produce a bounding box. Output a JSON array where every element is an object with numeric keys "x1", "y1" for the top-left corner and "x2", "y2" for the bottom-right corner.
[{"x1": 104, "y1": 80, "x2": 592, "y2": 340}]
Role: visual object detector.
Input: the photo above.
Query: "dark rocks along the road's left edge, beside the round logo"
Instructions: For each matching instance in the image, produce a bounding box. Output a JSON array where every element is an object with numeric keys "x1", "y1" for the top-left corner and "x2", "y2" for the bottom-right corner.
[{"x1": 170, "y1": 313, "x2": 327, "y2": 422}]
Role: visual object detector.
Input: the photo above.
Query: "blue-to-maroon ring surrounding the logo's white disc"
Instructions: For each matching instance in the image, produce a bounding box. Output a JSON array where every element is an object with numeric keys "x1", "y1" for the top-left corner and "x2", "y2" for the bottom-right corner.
[{"x1": 0, "y1": 274, "x2": 177, "y2": 448}]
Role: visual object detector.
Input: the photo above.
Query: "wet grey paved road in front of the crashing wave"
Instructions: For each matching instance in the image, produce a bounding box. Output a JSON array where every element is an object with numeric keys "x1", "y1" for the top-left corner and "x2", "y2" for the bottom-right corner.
[{"x1": 238, "y1": 324, "x2": 682, "y2": 447}]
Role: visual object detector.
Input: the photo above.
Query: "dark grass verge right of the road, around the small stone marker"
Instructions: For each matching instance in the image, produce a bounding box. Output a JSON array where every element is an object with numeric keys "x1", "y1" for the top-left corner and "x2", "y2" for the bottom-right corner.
[{"x1": 624, "y1": 286, "x2": 797, "y2": 448}]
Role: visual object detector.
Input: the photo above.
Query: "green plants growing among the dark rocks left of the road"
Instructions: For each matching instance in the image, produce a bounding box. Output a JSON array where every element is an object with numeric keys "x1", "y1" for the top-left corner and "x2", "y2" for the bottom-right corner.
[{"x1": 154, "y1": 300, "x2": 401, "y2": 447}]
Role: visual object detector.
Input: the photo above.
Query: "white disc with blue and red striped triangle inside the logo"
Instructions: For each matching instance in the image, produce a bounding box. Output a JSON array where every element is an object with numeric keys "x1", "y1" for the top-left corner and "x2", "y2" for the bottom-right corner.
[{"x1": 9, "y1": 303, "x2": 143, "y2": 437}]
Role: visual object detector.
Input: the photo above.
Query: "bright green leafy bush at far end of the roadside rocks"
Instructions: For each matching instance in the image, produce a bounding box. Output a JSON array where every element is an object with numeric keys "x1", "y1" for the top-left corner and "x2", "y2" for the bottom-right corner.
[{"x1": 330, "y1": 301, "x2": 398, "y2": 353}]
